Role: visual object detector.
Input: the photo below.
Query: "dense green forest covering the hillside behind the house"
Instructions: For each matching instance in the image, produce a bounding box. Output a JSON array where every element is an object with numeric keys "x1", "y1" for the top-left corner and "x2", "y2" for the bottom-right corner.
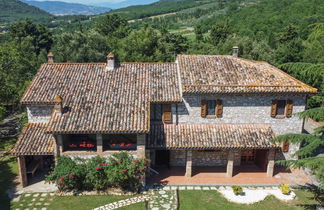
[{"x1": 0, "y1": 0, "x2": 324, "y2": 120}]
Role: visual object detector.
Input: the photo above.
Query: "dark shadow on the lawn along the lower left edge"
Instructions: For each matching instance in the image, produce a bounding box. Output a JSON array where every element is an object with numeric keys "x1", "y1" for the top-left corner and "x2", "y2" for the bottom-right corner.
[{"x1": 0, "y1": 155, "x2": 17, "y2": 210}]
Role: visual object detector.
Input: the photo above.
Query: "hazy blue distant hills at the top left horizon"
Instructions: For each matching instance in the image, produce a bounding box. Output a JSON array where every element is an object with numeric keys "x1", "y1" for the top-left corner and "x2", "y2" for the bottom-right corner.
[{"x1": 22, "y1": 0, "x2": 111, "y2": 15}]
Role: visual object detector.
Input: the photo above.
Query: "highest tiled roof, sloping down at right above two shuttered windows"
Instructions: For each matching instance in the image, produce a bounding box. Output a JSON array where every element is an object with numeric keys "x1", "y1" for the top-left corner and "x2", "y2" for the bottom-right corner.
[{"x1": 177, "y1": 55, "x2": 316, "y2": 93}]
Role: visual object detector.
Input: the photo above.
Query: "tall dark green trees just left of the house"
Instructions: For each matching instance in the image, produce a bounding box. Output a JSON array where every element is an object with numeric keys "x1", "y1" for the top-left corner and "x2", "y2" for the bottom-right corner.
[{"x1": 0, "y1": 20, "x2": 53, "y2": 119}]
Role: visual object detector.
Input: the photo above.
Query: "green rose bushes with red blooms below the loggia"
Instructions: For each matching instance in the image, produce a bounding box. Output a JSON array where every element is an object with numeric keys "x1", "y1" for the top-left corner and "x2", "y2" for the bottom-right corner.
[{"x1": 46, "y1": 152, "x2": 148, "y2": 192}]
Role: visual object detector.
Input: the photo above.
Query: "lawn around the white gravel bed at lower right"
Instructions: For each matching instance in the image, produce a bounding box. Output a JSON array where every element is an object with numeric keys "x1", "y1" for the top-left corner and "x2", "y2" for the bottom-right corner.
[{"x1": 179, "y1": 190, "x2": 318, "y2": 210}]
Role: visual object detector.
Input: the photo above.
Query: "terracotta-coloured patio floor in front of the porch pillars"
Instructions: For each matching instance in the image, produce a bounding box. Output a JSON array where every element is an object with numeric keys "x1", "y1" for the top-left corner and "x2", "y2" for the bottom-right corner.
[{"x1": 147, "y1": 166, "x2": 312, "y2": 185}]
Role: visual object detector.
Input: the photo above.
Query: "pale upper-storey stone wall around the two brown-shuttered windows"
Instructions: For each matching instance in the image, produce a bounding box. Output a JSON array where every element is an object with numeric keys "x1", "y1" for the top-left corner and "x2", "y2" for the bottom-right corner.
[{"x1": 177, "y1": 95, "x2": 306, "y2": 134}]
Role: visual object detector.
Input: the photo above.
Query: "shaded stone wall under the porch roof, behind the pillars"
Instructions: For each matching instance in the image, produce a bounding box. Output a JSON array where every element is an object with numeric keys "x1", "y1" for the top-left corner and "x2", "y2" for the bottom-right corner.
[{"x1": 170, "y1": 150, "x2": 241, "y2": 166}]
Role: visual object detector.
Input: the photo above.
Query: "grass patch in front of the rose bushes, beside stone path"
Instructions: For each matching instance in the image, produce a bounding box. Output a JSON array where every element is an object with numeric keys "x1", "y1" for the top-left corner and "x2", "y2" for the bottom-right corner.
[{"x1": 48, "y1": 195, "x2": 145, "y2": 210}]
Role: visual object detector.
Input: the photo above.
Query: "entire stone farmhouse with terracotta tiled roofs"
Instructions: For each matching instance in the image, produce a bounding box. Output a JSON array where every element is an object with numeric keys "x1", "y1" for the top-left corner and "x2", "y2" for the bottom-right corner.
[{"x1": 12, "y1": 50, "x2": 316, "y2": 186}]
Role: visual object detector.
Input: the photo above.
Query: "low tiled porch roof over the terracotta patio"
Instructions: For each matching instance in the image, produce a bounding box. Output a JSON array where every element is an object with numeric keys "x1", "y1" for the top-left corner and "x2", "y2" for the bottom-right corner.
[{"x1": 147, "y1": 124, "x2": 277, "y2": 149}]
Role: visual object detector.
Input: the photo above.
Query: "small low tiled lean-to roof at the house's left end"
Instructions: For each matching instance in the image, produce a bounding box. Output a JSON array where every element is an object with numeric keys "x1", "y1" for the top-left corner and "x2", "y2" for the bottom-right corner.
[{"x1": 11, "y1": 123, "x2": 55, "y2": 156}]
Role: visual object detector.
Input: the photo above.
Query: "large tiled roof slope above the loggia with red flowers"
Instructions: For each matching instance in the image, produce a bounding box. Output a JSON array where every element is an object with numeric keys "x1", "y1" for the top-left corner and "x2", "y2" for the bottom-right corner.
[{"x1": 40, "y1": 64, "x2": 150, "y2": 133}]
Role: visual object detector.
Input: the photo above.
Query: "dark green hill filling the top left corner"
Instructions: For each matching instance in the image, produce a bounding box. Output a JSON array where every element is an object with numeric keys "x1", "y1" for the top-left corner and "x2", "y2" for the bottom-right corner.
[{"x1": 0, "y1": 0, "x2": 52, "y2": 24}]
